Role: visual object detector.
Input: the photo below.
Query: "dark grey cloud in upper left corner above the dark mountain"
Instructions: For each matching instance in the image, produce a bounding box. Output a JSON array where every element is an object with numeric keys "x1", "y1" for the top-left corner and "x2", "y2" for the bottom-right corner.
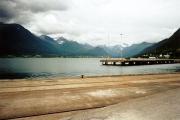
[{"x1": 0, "y1": 0, "x2": 68, "y2": 24}]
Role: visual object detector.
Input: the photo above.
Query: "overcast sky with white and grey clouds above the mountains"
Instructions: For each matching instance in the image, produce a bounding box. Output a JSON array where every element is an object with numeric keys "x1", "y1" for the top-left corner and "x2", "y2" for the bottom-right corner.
[{"x1": 0, "y1": 0, "x2": 180, "y2": 45}]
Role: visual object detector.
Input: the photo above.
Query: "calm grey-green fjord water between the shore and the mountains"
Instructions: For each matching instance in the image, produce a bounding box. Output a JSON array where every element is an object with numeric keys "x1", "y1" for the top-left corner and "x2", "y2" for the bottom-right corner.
[{"x1": 0, "y1": 58, "x2": 180, "y2": 79}]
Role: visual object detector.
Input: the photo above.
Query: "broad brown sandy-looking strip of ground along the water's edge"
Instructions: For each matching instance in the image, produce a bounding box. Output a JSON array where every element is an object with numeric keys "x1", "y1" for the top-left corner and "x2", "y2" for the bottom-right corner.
[{"x1": 0, "y1": 73, "x2": 180, "y2": 120}]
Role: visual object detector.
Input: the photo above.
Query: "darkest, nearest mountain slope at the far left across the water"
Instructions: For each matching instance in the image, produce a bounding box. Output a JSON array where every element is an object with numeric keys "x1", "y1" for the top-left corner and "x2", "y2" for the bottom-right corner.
[{"x1": 0, "y1": 23, "x2": 59, "y2": 56}]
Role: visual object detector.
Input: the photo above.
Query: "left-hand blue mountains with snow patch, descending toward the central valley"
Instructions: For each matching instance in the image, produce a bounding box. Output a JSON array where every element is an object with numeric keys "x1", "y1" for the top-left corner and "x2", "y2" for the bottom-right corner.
[{"x1": 0, "y1": 23, "x2": 108, "y2": 57}]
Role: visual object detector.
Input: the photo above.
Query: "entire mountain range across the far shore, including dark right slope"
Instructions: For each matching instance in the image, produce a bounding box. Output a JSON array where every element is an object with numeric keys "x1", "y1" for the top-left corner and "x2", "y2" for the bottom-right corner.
[{"x1": 0, "y1": 23, "x2": 180, "y2": 57}]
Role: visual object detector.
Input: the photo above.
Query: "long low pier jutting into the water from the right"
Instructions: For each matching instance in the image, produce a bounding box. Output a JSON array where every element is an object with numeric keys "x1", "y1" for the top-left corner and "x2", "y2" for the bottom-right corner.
[{"x1": 100, "y1": 58, "x2": 180, "y2": 66}]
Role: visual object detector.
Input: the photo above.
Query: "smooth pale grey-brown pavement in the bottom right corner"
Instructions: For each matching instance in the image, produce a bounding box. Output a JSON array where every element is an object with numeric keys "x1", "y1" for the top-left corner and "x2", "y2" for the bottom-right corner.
[{"x1": 61, "y1": 88, "x2": 180, "y2": 120}]
